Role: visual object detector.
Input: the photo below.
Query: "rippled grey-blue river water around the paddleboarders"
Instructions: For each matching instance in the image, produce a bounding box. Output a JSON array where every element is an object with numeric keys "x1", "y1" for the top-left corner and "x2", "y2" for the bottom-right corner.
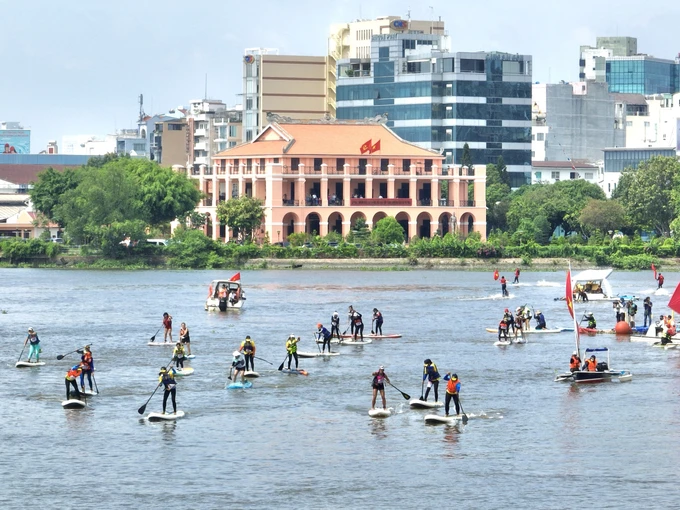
[{"x1": 0, "y1": 269, "x2": 680, "y2": 509}]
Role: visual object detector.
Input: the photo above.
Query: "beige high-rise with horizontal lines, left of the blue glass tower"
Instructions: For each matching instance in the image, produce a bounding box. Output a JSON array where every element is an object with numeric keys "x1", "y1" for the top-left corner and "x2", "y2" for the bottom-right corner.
[{"x1": 243, "y1": 48, "x2": 335, "y2": 142}]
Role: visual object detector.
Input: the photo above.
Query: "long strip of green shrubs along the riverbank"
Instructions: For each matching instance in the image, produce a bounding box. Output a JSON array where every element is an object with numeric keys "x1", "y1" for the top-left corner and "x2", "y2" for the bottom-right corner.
[{"x1": 0, "y1": 230, "x2": 680, "y2": 270}]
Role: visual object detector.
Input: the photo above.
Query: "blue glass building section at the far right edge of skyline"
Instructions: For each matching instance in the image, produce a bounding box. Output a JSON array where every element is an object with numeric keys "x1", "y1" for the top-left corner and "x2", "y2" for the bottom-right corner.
[{"x1": 606, "y1": 55, "x2": 680, "y2": 95}]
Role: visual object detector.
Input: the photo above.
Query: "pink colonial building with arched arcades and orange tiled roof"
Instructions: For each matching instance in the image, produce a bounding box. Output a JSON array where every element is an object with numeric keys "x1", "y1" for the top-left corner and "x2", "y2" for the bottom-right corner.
[{"x1": 199, "y1": 121, "x2": 486, "y2": 243}]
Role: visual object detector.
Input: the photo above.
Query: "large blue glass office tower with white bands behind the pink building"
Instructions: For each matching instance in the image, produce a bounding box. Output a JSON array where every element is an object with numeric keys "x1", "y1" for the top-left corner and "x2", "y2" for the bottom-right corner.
[{"x1": 336, "y1": 33, "x2": 532, "y2": 187}]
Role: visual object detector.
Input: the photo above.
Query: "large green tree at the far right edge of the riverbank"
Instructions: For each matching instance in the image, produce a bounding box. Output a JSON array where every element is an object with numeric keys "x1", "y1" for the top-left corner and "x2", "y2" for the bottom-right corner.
[{"x1": 614, "y1": 156, "x2": 680, "y2": 235}]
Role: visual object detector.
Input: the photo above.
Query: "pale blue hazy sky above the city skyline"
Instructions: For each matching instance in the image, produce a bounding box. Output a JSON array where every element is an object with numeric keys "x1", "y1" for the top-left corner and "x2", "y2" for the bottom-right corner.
[{"x1": 0, "y1": 0, "x2": 680, "y2": 149}]
